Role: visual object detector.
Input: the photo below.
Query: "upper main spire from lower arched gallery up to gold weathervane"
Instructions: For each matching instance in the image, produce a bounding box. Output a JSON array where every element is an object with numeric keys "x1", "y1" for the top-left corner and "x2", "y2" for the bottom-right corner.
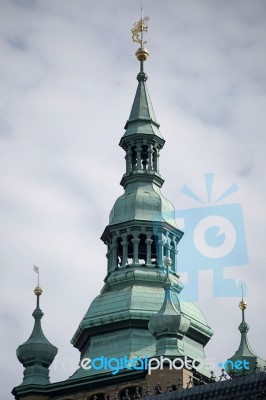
[{"x1": 97, "y1": 17, "x2": 183, "y2": 278}]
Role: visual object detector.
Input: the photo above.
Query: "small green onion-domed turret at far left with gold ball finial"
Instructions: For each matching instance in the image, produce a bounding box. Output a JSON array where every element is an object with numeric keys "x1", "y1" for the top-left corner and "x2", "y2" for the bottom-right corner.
[{"x1": 17, "y1": 286, "x2": 57, "y2": 385}]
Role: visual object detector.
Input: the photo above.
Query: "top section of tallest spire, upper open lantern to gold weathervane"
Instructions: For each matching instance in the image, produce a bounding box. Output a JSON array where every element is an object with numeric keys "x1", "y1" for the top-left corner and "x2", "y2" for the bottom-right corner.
[{"x1": 119, "y1": 16, "x2": 165, "y2": 188}]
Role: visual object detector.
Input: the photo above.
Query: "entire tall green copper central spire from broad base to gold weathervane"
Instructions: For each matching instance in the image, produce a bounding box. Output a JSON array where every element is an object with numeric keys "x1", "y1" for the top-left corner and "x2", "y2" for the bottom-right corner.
[{"x1": 70, "y1": 17, "x2": 212, "y2": 381}]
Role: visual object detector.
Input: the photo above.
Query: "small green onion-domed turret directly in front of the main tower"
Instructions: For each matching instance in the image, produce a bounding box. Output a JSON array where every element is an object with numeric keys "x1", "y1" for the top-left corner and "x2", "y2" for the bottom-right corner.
[{"x1": 148, "y1": 257, "x2": 190, "y2": 356}]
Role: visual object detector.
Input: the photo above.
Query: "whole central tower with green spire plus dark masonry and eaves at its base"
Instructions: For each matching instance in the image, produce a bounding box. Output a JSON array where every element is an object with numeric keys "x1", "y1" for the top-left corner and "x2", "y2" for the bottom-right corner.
[{"x1": 13, "y1": 13, "x2": 213, "y2": 400}]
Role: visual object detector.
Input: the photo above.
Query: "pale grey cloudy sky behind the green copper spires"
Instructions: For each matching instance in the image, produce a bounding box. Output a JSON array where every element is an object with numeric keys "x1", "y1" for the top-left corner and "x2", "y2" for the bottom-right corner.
[{"x1": 0, "y1": 0, "x2": 266, "y2": 399}]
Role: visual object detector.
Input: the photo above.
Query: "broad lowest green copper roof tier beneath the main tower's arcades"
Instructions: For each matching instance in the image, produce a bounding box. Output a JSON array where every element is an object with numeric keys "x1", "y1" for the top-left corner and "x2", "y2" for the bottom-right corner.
[{"x1": 71, "y1": 267, "x2": 213, "y2": 379}]
